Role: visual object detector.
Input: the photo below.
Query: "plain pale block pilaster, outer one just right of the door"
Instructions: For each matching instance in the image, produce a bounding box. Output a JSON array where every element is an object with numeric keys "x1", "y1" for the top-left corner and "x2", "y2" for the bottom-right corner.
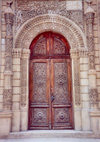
[{"x1": 79, "y1": 49, "x2": 91, "y2": 131}]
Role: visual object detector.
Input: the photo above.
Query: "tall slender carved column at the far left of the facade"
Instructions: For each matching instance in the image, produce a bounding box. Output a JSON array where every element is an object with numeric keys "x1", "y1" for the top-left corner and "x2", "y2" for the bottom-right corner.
[{"x1": 3, "y1": 2, "x2": 14, "y2": 110}]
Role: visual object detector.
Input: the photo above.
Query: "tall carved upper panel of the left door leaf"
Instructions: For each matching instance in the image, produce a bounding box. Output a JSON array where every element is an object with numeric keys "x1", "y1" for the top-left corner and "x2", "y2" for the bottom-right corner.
[{"x1": 33, "y1": 63, "x2": 47, "y2": 103}]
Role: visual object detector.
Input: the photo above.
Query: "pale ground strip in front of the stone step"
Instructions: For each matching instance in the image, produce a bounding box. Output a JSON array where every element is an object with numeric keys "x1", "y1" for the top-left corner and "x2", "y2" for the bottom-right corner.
[{"x1": 0, "y1": 138, "x2": 100, "y2": 142}]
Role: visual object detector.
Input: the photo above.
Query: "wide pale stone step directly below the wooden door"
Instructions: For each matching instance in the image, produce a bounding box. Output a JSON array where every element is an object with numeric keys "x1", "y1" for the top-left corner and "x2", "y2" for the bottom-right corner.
[{"x1": 6, "y1": 130, "x2": 100, "y2": 139}]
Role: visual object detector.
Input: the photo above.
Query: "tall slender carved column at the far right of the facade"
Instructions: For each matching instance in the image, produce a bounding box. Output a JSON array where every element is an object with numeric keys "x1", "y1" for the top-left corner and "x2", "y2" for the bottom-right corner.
[{"x1": 85, "y1": 0, "x2": 98, "y2": 107}]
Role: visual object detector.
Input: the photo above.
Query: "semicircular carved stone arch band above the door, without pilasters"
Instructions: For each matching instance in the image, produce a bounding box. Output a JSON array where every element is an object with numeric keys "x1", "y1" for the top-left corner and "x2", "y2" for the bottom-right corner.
[{"x1": 14, "y1": 14, "x2": 87, "y2": 48}]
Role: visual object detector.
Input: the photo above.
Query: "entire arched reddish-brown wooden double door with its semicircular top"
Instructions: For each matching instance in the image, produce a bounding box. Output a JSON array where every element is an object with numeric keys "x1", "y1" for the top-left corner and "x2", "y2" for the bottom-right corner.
[{"x1": 29, "y1": 32, "x2": 73, "y2": 129}]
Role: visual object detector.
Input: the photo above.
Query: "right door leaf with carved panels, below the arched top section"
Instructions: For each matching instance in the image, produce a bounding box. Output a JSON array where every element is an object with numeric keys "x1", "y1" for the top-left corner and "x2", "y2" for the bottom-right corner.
[{"x1": 52, "y1": 59, "x2": 72, "y2": 129}]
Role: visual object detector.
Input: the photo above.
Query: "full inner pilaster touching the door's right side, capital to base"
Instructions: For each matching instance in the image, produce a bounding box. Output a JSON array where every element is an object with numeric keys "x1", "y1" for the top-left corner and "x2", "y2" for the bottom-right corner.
[{"x1": 70, "y1": 49, "x2": 82, "y2": 130}]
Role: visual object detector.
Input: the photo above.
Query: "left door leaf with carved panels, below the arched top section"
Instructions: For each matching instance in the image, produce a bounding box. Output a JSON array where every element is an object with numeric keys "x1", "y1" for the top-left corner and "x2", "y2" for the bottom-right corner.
[{"x1": 29, "y1": 59, "x2": 49, "y2": 129}]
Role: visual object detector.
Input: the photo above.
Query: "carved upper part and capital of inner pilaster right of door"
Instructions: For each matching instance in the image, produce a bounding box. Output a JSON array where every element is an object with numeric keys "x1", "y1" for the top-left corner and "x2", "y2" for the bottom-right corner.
[{"x1": 70, "y1": 49, "x2": 81, "y2": 106}]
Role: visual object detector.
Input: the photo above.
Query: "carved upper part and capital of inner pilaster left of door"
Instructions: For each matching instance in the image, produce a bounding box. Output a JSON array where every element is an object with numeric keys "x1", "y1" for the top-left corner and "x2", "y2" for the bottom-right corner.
[{"x1": 21, "y1": 49, "x2": 30, "y2": 107}]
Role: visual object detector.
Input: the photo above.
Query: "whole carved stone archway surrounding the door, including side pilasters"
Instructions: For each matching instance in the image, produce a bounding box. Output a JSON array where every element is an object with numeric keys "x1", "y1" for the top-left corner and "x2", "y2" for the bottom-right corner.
[{"x1": 12, "y1": 14, "x2": 90, "y2": 131}]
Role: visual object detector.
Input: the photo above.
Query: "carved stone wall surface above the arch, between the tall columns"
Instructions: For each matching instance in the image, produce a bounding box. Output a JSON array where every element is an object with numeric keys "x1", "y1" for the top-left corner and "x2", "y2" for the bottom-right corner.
[{"x1": 15, "y1": 0, "x2": 83, "y2": 31}]
